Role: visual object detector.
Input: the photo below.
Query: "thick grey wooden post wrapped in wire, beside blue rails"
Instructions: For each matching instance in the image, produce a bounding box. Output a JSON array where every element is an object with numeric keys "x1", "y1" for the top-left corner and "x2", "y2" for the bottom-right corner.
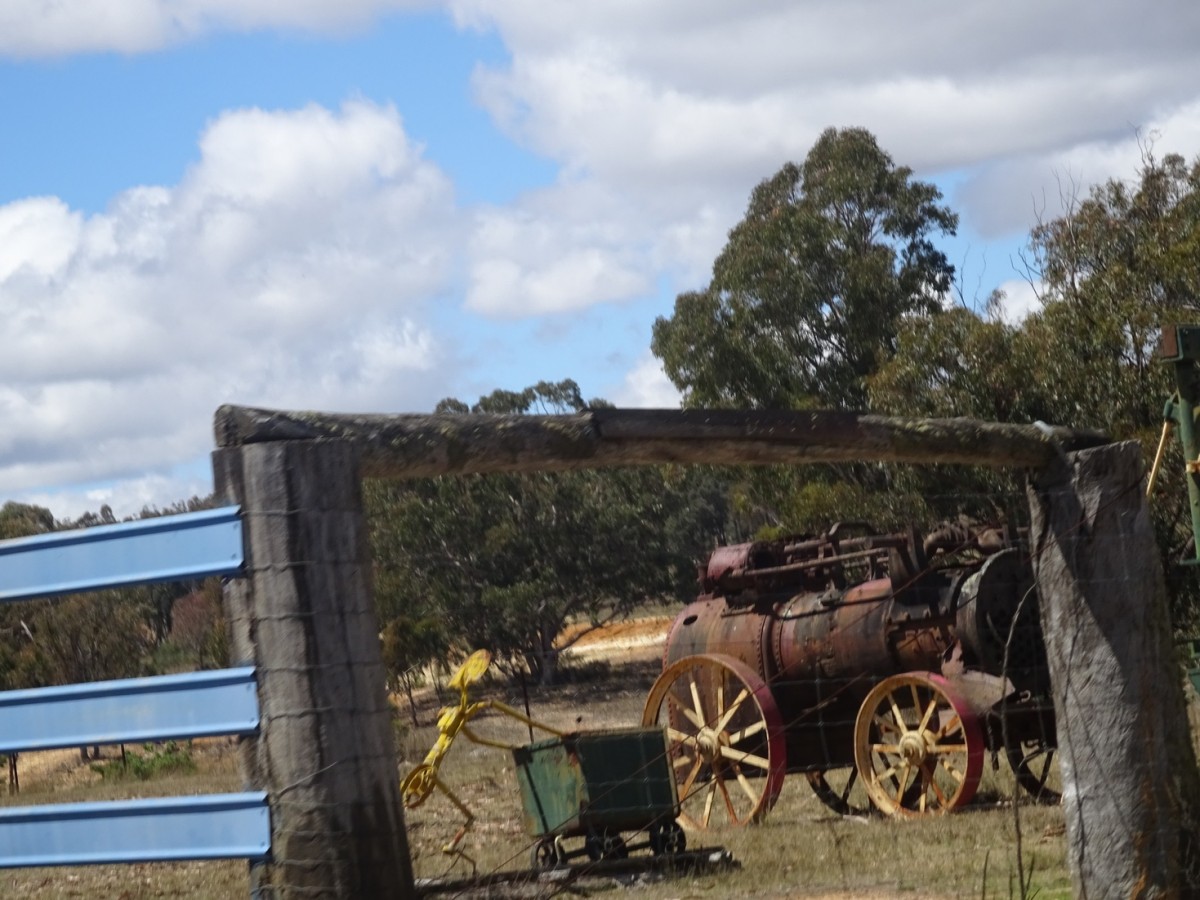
[{"x1": 214, "y1": 440, "x2": 415, "y2": 900}]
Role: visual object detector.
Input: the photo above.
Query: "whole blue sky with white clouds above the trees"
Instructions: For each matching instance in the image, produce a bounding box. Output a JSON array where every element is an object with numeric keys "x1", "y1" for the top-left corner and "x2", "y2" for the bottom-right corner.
[{"x1": 0, "y1": 0, "x2": 1200, "y2": 518}]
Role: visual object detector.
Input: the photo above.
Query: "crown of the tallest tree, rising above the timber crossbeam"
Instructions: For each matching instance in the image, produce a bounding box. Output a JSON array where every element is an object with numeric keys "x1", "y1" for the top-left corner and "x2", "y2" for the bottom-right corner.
[{"x1": 652, "y1": 128, "x2": 958, "y2": 409}]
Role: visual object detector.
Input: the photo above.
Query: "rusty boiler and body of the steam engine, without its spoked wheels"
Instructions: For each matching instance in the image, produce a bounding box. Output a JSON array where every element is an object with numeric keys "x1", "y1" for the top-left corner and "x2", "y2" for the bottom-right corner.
[{"x1": 664, "y1": 523, "x2": 1054, "y2": 772}]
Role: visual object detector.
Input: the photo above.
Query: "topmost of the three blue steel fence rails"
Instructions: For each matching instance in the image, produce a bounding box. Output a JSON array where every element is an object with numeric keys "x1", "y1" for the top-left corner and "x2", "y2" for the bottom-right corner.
[{"x1": 0, "y1": 506, "x2": 245, "y2": 601}]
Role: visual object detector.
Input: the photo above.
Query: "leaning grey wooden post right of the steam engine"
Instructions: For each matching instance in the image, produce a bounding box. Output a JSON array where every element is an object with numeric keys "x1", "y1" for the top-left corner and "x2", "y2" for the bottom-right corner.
[{"x1": 1028, "y1": 442, "x2": 1200, "y2": 898}]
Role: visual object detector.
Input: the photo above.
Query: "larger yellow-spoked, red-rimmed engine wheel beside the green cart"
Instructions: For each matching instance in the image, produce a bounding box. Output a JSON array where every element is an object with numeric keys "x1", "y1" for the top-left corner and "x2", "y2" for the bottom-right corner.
[{"x1": 642, "y1": 654, "x2": 787, "y2": 828}]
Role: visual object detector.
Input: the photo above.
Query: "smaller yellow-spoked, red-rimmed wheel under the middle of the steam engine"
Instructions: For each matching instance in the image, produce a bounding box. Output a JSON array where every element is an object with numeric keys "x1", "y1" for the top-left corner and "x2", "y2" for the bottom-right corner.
[{"x1": 854, "y1": 672, "x2": 984, "y2": 816}]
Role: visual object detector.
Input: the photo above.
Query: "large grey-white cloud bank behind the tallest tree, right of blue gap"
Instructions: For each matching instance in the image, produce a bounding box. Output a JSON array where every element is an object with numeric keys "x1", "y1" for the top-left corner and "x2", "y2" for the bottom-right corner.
[{"x1": 450, "y1": 0, "x2": 1200, "y2": 348}]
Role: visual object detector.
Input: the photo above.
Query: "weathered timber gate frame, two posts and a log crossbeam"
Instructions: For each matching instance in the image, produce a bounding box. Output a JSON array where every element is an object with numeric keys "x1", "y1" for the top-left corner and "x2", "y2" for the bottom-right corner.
[{"x1": 0, "y1": 407, "x2": 1200, "y2": 900}]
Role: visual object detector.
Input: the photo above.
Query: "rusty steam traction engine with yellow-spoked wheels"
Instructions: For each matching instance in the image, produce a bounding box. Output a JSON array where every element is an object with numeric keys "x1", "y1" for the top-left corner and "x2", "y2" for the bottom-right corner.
[{"x1": 643, "y1": 524, "x2": 1057, "y2": 828}]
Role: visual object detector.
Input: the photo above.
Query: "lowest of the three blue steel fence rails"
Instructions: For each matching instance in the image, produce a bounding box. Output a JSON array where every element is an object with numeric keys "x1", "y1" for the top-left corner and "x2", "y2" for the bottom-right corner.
[{"x1": 0, "y1": 792, "x2": 271, "y2": 869}]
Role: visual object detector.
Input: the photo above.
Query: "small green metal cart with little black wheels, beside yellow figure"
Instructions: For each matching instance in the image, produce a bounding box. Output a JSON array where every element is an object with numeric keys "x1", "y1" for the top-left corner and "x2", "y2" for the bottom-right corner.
[{"x1": 512, "y1": 728, "x2": 686, "y2": 869}]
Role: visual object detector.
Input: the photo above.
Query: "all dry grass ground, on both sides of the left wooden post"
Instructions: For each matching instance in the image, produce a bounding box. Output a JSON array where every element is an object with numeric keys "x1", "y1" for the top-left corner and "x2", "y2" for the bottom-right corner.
[{"x1": 0, "y1": 655, "x2": 1070, "y2": 900}]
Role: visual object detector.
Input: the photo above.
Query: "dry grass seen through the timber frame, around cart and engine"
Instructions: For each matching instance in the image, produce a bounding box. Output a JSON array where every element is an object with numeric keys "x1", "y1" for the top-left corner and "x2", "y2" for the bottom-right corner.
[{"x1": 404, "y1": 661, "x2": 1070, "y2": 900}]
